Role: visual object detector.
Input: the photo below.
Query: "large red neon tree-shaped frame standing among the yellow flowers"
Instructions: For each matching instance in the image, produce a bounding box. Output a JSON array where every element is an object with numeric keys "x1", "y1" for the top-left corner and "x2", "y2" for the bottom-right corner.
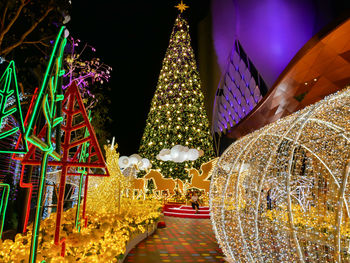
[{"x1": 22, "y1": 82, "x2": 109, "y2": 252}]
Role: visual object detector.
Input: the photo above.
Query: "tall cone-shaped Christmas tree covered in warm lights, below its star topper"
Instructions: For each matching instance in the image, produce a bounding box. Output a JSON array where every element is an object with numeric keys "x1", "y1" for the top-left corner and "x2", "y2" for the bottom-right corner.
[{"x1": 139, "y1": 12, "x2": 215, "y2": 182}]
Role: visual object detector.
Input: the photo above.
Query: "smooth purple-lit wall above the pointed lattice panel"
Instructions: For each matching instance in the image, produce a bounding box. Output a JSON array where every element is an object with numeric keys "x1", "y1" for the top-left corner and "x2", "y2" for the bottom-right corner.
[{"x1": 211, "y1": 0, "x2": 340, "y2": 87}]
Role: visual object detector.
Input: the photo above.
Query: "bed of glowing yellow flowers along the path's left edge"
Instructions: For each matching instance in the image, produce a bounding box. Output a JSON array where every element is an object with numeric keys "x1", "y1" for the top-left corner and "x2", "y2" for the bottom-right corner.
[{"x1": 0, "y1": 200, "x2": 162, "y2": 263}]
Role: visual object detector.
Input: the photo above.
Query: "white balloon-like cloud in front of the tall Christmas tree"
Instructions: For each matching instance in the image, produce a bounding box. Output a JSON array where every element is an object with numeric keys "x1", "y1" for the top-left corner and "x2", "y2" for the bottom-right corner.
[{"x1": 156, "y1": 145, "x2": 204, "y2": 163}]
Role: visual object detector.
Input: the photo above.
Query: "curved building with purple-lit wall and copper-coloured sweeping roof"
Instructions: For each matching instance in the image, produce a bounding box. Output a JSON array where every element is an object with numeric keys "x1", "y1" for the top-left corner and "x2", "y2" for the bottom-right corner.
[{"x1": 199, "y1": 0, "x2": 350, "y2": 154}]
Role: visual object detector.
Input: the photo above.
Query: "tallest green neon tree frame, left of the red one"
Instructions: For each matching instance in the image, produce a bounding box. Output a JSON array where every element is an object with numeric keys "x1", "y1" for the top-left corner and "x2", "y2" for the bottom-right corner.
[{"x1": 25, "y1": 27, "x2": 67, "y2": 263}]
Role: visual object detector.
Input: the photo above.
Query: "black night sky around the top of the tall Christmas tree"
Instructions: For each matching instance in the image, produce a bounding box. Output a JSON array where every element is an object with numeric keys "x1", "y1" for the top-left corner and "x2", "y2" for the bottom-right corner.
[{"x1": 67, "y1": 0, "x2": 210, "y2": 155}]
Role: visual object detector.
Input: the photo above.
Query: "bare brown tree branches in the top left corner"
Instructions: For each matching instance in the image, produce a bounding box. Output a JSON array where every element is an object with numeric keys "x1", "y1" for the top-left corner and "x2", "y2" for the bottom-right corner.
[{"x1": 0, "y1": 0, "x2": 69, "y2": 57}]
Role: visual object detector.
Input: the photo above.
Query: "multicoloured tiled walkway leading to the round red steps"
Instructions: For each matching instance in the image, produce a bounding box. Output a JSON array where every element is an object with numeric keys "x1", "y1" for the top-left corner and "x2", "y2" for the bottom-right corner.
[{"x1": 124, "y1": 216, "x2": 226, "y2": 263}]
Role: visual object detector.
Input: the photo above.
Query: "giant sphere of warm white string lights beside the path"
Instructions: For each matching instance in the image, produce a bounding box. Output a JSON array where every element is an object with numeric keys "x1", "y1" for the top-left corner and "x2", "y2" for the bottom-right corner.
[{"x1": 210, "y1": 88, "x2": 350, "y2": 262}]
